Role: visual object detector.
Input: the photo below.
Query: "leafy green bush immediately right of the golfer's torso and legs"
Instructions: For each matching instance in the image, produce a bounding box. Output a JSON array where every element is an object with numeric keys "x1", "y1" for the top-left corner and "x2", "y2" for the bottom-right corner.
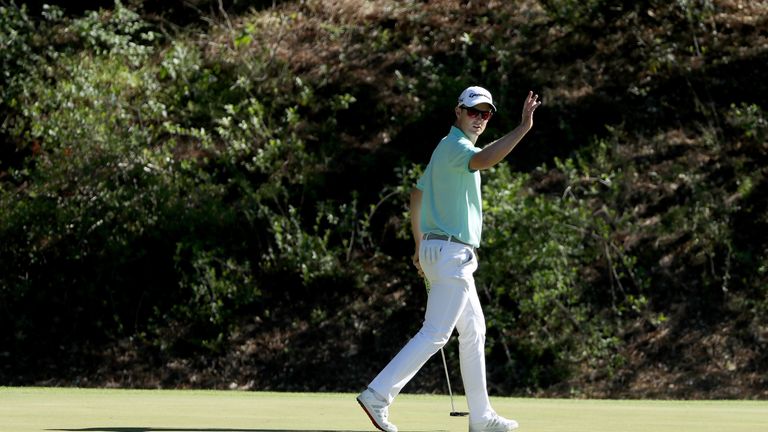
[{"x1": 478, "y1": 160, "x2": 646, "y2": 388}]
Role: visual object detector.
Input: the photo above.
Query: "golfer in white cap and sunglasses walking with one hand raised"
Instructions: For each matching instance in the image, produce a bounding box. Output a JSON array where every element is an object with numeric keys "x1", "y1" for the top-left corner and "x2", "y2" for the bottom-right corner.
[{"x1": 357, "y1": 86, "x2": 541, "y2": 432}]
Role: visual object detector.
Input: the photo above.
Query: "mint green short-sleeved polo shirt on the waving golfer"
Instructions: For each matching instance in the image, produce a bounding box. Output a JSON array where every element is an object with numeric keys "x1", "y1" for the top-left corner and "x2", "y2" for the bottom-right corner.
[{"x1": 416, "y1": 126, "x2": 483, "y2": 247}]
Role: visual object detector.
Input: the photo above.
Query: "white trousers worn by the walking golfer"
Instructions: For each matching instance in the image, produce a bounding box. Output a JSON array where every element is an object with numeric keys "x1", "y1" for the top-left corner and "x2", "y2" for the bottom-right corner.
[{"x1": 368, "y1": 240, "x2": 493, "y2": 423}]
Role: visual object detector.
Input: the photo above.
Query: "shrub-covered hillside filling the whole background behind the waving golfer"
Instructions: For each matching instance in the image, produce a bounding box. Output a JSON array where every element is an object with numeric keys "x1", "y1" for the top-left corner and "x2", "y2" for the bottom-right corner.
[{"x1": 0, "y1": 0, "x2": 768, "y2": 398}]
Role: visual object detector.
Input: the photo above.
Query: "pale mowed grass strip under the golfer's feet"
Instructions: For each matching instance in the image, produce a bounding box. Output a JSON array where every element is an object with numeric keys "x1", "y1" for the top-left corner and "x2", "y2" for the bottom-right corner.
[{"x1": 0, "y1": 387, "x2": 768, "y2": 432}]
